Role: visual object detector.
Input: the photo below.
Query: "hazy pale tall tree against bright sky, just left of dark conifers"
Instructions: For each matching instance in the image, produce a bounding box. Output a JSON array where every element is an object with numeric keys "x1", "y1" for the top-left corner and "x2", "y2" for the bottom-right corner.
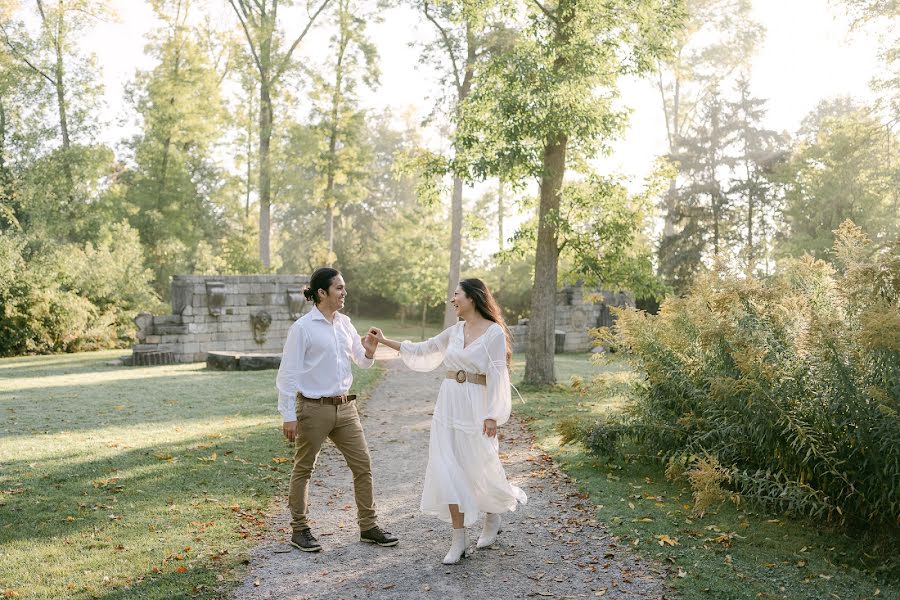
[{"x1": 656, "y1": 0, "x2": 765, "y2": 280}]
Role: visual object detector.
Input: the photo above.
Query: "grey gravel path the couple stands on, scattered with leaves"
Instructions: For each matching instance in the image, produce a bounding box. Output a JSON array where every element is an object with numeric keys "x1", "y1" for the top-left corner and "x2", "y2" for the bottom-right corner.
[{"x1": 234, "y1": 359, "x2": 667, "y2": 600}]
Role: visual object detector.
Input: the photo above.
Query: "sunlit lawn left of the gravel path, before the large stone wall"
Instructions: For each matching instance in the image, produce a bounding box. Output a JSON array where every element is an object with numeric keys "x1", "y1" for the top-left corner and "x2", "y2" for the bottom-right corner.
[{"x1": 0, "y1": 350, "x2": 381, "y2": 599}]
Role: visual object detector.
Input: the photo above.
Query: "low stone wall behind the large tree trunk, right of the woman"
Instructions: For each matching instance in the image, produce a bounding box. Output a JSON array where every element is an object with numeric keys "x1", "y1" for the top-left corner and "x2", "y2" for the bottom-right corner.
[{"x1": 509, "y1": 285, "x2": 634, "y2": 353}]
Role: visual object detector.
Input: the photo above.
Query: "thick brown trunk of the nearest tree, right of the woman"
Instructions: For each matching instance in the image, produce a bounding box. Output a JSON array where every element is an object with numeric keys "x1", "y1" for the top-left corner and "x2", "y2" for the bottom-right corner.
[{"x1": 525, "y1": 134, "x2": 568, "y2": 384}]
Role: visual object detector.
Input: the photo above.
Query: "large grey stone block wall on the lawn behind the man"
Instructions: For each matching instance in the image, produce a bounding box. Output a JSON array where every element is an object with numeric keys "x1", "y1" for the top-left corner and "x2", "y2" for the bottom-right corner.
[{"x1": 131, "y1": 275, "x2": 312, "y2": 368}]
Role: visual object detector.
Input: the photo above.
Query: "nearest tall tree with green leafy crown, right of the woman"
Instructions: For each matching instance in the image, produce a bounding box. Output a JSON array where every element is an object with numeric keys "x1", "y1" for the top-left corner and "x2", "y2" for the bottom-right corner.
[{"x1": 456, "y1": 0, "x2": 681, "y2": 384}]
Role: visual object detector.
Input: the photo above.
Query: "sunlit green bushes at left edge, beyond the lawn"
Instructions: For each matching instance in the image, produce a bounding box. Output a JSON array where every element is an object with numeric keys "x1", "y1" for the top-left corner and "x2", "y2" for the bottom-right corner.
[{"x1": 0, "y1": 223, "x2": 159, "y2": 356}]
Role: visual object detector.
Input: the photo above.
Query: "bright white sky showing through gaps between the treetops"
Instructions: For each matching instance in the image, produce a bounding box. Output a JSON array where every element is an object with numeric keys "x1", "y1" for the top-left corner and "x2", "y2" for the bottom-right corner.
[{"x1": 85, "y1": 0, "x2": 877, "y2": 251}]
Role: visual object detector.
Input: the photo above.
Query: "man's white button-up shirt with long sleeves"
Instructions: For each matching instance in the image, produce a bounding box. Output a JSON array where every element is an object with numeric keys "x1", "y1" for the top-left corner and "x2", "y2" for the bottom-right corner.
[{"x1": 275, "y1": 307, "x2": 375, "y2": 423}]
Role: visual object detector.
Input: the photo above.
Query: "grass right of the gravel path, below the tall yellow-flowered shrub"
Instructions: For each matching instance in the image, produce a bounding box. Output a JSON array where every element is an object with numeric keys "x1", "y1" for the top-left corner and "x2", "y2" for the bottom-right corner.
[{"x1": 513, "y1": 354, "x2": 900, "y2": 600}]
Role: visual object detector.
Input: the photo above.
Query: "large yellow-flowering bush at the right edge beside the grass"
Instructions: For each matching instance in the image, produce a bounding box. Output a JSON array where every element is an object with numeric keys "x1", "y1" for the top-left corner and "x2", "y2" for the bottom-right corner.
[{"x1": 576, "y1": 222, "x2": 900, "y2": 527}]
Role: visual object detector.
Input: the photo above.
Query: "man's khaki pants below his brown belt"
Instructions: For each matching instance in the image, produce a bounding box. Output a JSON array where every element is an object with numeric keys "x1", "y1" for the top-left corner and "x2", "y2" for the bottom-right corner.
[{"x1": 288, "y1": 399, "x2": 375, "y2": 531}]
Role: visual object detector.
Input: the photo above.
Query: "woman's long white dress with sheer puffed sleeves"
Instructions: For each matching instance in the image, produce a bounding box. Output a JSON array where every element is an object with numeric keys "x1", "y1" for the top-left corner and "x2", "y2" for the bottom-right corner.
[{"x1": 400, "y1": 321, "x2": 528, "y2": 527}]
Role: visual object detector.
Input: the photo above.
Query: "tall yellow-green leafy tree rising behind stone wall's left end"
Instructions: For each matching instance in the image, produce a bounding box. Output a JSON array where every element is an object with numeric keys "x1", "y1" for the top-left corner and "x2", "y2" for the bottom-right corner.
[{"x1": 123, "y1": 0, "x2": 232, "y2": 295}]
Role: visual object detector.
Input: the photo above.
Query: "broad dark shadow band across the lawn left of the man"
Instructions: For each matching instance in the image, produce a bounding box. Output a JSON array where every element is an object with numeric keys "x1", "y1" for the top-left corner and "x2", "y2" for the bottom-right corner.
[{"x1": 0, "y1": 427, "x2": 290, "y2": 544}]
